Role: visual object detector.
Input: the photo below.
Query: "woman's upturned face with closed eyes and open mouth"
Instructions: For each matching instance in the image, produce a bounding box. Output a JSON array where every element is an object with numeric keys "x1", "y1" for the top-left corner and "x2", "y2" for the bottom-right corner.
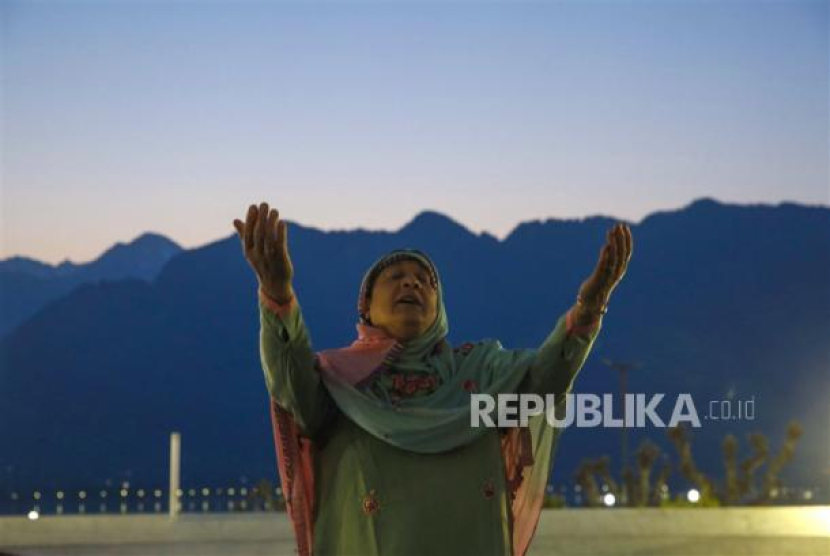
[{"x1": 368, "y1": 260, "x2": 438, "y2": 342}]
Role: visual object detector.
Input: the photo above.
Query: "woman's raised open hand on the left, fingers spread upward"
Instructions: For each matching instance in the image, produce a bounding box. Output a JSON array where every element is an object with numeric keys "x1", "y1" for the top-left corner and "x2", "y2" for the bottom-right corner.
[{"x1": 233, "y1": 203, "x2": 294, "y2": 304}]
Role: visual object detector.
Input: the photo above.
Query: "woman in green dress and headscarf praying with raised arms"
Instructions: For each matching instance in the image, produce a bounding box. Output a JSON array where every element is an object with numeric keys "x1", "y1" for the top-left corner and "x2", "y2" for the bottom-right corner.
[{"x1": 234, "y1": 203, "x2": 632, "y2": 556}]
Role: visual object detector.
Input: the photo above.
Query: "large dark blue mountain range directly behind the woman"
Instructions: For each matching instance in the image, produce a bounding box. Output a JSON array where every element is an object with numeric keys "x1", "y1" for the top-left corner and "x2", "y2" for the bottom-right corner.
[{"x1": 0, "y1": 199, "x2": 830, "y2": 496}]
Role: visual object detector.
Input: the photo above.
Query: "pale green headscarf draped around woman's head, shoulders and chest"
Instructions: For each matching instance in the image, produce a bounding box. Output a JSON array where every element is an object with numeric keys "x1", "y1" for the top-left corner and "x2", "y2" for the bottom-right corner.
[{"x1": 320, "y1": 249, "x2": 536, "y2": 453}]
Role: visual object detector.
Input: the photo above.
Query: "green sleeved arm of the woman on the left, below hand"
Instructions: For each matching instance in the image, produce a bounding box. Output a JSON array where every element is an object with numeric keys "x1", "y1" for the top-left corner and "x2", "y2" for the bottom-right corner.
[{"x1": 259, "y1": 290, "x2": 330, "y2": 436}]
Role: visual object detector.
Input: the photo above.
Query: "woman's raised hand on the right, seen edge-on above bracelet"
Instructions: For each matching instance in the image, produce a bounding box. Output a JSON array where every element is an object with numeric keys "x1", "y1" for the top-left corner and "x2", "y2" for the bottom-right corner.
[{"x1": 579, "y1": 224, "x2": 633, "y2": 311}]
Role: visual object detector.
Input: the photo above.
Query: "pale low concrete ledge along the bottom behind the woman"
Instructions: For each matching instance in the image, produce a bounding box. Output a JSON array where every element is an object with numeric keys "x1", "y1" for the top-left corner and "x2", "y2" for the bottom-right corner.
[{"x1": 0, "y1": 507, "x2": 830, "y2": 556}]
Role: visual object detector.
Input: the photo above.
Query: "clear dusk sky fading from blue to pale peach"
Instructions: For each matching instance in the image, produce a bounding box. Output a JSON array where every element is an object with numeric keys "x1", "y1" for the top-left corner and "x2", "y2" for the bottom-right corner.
[{"x1": 0, "y1": 1, "x2": 830, "y2": 262}]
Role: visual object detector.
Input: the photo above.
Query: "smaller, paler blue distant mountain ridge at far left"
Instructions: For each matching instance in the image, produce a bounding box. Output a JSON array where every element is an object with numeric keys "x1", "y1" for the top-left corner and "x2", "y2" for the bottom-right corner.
[{"x1": 0, "y1": 233, "x2": 182, "y2": 335}]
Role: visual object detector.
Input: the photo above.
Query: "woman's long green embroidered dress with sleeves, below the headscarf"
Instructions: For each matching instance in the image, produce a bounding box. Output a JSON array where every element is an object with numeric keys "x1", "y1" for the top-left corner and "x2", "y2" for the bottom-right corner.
[{"x1": 260, "y1": 305, "x2": 599, "y2": 556}]
